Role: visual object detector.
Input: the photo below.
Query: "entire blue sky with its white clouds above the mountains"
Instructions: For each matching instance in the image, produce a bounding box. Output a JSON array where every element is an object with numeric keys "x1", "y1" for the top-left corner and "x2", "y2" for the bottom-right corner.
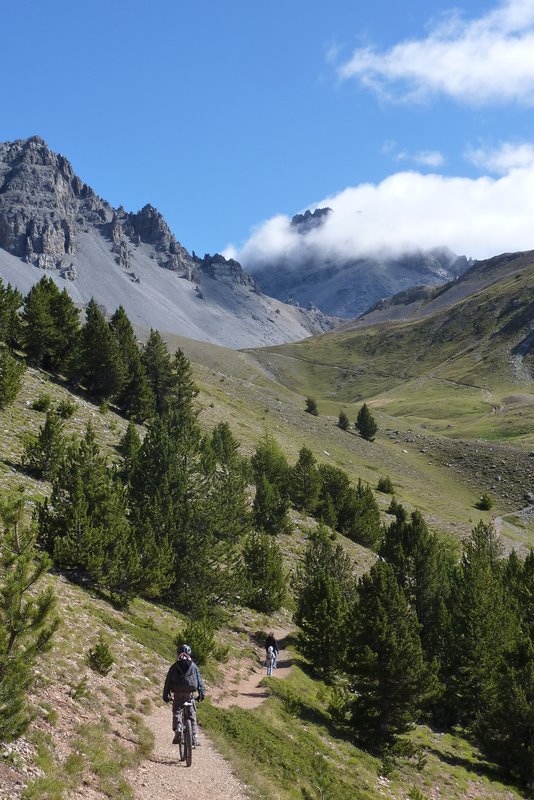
[{"x1": 0, "y1": 0, "x2": 534, "y2": 267}]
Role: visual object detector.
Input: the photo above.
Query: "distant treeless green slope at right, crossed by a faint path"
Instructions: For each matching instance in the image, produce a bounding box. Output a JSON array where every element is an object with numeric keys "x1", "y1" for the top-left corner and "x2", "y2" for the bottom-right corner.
[{"x1": 247, "y1": 264, "x2": 534, "y2": 441}]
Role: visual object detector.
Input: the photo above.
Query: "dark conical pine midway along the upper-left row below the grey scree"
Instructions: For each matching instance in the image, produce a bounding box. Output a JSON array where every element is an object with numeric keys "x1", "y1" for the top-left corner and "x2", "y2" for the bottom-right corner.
[{"x1": 78, "y1": 299, "x2": 126, "y2": 400}]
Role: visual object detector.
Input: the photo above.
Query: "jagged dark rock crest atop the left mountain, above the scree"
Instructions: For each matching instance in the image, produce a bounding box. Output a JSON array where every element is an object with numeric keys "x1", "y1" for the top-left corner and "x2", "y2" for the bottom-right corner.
[{"x1": 0, "y1": 136, "x2": 194, "y2": 280}]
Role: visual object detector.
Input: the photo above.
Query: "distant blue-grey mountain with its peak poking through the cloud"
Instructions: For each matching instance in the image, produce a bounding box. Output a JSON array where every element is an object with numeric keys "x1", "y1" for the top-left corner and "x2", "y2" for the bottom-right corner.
[{"x1": 249, "y1": 208, "x2": 469, "y2": 318}]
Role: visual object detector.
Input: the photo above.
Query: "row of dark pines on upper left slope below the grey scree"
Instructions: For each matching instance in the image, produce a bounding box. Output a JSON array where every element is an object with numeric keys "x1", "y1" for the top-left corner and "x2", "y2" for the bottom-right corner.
[{"x1": 0, "y1": 276, "x2": 199, "y2": 423}]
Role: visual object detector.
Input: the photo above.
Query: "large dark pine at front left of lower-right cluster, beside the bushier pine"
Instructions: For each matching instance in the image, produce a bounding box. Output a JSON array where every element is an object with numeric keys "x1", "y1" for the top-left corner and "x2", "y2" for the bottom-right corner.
[{"x1": 345, "y1": 561, "x2": 437, "y2": 749}]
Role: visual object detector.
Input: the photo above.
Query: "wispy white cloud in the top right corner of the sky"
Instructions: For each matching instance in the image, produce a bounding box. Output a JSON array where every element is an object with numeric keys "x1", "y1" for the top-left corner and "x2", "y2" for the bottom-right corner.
[{"x1": 338, "y1": 0, "x2": 534, "y2": 105}]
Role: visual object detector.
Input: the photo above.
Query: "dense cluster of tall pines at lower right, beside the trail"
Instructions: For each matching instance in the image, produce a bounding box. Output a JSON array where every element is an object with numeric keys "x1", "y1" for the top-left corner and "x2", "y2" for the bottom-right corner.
[{"x1": 295, "y1": 503, "x2": 534, "y2": 788}]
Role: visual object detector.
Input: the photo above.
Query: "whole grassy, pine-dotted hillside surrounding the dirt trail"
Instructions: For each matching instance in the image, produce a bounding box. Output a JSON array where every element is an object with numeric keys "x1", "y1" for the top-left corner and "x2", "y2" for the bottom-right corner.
[{"x1": 0, "y1": 258, "x2": 534, "y2": 800}]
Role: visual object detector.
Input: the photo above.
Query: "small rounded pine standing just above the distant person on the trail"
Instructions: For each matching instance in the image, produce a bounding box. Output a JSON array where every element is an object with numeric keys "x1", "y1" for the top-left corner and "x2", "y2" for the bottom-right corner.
[{"x1": 243, "y1": 533, "x2": 287, "y2": 614}]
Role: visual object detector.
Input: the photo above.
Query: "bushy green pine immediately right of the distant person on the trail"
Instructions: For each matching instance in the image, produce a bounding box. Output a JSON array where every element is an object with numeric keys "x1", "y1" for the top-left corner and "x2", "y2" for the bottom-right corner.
[{"x1": 294, "y1": 526, "x2": 354, "y2": 673}]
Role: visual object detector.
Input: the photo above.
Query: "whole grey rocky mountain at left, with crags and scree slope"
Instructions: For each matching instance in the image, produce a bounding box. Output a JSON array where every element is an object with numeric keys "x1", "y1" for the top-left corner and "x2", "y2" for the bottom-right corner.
[{"x1": 0, "y1": 136, "x2": 334, "y2": 347}]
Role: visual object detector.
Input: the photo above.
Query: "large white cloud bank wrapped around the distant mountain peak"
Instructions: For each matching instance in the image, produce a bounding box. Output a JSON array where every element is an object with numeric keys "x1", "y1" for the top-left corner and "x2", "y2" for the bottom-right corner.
[{"x1": 237, "y1": 162, "x2": 534, "y2": 271}]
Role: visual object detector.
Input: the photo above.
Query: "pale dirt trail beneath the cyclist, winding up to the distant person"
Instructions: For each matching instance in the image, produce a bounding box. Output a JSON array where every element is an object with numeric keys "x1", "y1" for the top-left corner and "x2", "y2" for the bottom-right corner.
[{"x1": 130, "y1": 629, "x2": 291, "y2": 800}]
